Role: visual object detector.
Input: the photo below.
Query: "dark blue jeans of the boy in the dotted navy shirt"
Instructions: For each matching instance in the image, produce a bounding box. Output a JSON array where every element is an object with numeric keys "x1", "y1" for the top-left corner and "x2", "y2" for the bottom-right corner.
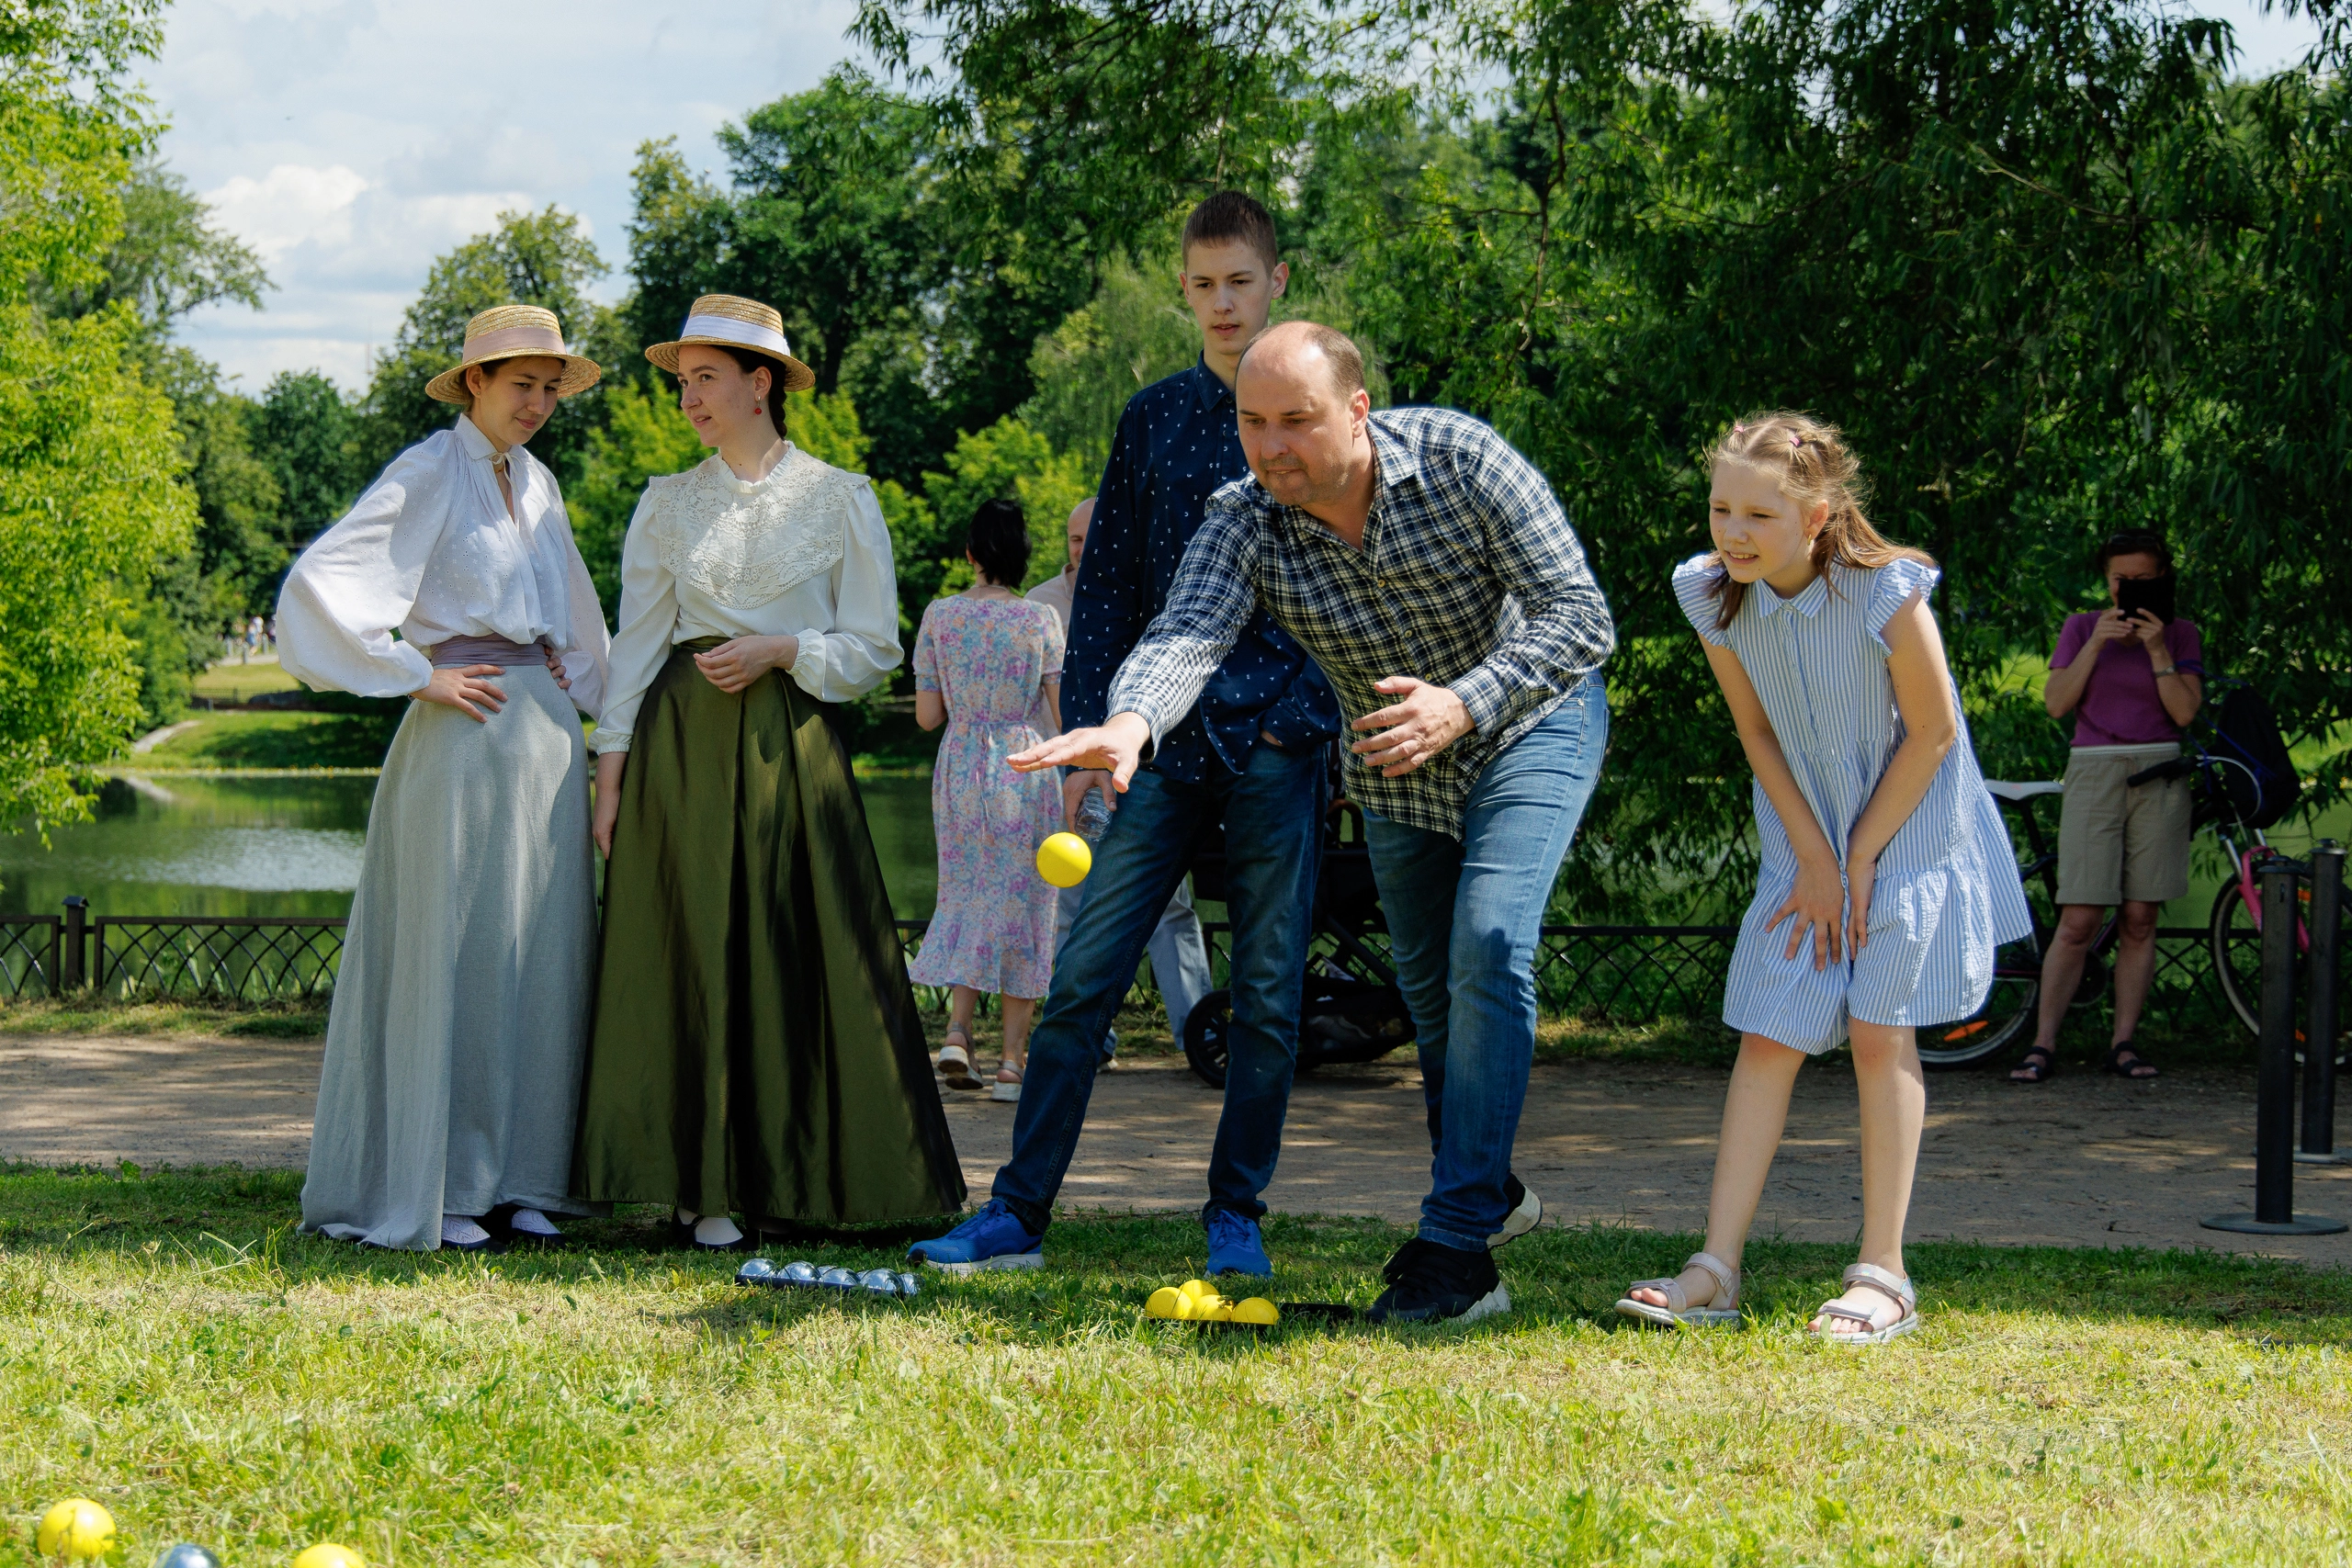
[{"x1": 995, "y1": 743, "x2": 1324, "y2": 1235}]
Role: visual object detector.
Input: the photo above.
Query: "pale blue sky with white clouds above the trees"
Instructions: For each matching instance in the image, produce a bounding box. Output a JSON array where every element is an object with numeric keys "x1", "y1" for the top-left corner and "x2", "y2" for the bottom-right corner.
[{"x1": 143, "y1": 0, "x2": 2310, "y2": 392}]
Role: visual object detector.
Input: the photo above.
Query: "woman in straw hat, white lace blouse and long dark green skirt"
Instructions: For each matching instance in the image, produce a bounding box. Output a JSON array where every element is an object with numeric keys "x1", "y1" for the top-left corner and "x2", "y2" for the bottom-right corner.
[{"x1": 574, "y1": 294, "x2": 965, "y2": 1248}]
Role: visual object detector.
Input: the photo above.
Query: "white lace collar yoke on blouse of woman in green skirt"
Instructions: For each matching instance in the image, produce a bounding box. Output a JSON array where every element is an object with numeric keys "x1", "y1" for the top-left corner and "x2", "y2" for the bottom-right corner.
[{"x1": 650, "y1": 445, "x2": 864, "y2": 611}]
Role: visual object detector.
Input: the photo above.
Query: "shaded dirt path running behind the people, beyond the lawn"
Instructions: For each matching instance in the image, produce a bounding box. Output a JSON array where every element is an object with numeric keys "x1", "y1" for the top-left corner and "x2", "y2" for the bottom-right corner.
[{"x1": 0, "y1": 1037, "x2": 2352, "y2": 1265}]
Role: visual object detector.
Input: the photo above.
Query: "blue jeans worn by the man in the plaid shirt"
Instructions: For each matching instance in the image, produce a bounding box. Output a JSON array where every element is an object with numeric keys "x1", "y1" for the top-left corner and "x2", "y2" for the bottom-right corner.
[{"x1": 1364, "y1": 674, "x2": 1609, "y2": 1251}]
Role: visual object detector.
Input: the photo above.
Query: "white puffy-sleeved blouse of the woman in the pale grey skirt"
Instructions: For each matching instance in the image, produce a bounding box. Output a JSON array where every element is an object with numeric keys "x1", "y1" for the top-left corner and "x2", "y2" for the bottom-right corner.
[{"x1": 277, "y1": 413, "x2": 612, "y2": 717}]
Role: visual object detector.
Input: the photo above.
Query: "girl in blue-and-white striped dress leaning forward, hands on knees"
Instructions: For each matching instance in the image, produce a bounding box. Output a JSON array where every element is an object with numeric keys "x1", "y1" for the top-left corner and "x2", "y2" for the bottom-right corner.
[{"x1": 1618, "y1": 413, "x2": 2030, "y2": 1345}]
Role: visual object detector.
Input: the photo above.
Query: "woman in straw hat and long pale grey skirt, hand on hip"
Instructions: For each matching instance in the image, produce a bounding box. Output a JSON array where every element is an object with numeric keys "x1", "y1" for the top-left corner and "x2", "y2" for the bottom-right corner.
[{"x1": 277, "y1": 306, "x2": 609, "y2": 1251}]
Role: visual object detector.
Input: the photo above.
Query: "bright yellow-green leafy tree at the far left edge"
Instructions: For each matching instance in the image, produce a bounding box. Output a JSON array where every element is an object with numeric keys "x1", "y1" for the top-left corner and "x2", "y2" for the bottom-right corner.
[{"x1": 0, "y1": 0, "x2": 195, "y2": 828}]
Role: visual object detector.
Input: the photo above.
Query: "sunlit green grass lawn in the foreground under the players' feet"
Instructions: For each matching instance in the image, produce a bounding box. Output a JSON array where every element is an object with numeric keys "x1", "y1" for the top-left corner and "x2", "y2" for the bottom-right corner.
[{"x1": 0, "y1": 1168, "x2": 2352, "y2": 1568}]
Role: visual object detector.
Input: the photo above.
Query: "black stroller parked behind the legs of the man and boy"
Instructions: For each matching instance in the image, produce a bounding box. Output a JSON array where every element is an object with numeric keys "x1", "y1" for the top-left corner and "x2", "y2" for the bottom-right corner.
[{"x1": 1183, "y1": 750, "x2": 1414, "y2": 1089}]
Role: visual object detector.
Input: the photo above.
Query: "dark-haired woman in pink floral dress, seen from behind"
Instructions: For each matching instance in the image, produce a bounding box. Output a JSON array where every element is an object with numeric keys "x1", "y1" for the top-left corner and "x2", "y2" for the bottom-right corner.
[{"x1": 908, "y1": 501, "x2": 1063, "y2": 1100}]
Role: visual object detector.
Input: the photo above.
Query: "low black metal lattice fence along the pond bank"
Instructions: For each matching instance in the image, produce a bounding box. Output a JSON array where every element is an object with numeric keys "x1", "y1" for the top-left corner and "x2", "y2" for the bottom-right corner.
[{"x1": 0, "y1": 900, "x2": 2230, "y2": 1030}]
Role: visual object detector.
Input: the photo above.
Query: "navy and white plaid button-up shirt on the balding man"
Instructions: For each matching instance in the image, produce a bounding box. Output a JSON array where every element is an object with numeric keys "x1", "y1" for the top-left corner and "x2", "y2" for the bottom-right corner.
[{"x1": 1108, "y1": 409, "x2": 1616, "y2": 837}]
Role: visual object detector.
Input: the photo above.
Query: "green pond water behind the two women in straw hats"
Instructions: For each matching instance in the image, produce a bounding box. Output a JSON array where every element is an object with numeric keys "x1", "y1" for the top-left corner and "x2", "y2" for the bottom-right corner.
[{"x1": 0, "y1": 773, "x2": 938, "y2": 919}]
